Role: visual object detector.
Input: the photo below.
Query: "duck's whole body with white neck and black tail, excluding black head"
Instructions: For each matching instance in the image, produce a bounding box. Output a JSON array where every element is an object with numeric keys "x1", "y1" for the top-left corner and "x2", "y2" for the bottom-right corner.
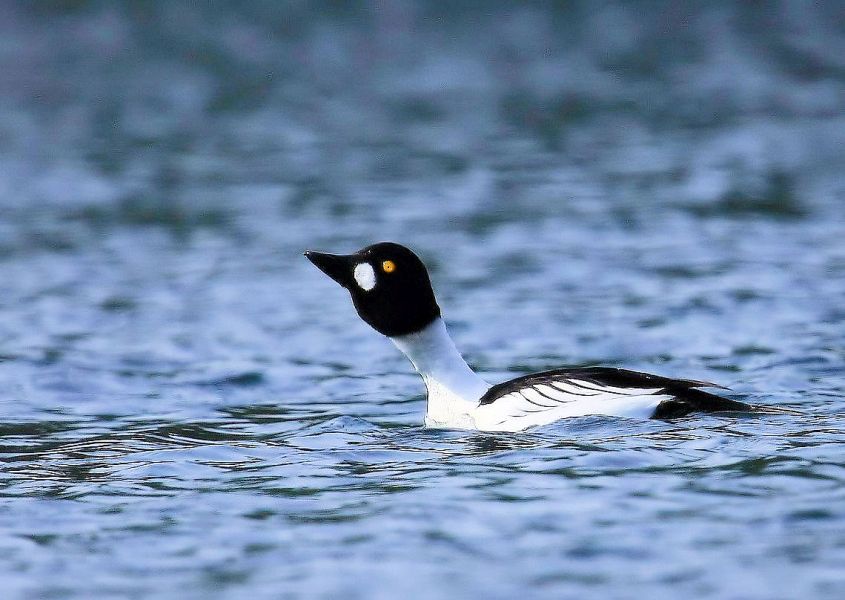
[{"x1": 391, "y1": 318, "x2": 748, "y2": 431}]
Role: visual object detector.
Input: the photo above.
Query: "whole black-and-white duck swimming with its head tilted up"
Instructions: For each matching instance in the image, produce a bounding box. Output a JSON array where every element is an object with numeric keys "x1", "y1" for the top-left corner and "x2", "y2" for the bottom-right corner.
[{"x1": 305, "y1": 242, "x2": 752, "y2": 431}]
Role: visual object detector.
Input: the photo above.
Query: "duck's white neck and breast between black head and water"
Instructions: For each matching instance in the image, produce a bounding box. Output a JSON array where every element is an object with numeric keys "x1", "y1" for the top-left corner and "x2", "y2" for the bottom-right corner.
[{"x1": 390, "y1": 317, "x2": 490, "y2": 428}]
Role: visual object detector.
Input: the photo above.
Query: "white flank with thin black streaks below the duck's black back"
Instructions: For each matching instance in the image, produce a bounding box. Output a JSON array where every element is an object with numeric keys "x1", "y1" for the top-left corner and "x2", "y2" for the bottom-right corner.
[{"x1": 475, "y1": 379, "x2": 672, "y2": 431}]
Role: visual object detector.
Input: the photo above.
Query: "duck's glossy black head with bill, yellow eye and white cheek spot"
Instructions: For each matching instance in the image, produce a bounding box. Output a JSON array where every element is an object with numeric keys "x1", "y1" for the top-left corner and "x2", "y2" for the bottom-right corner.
[{"x1": 305, "y1": 242, "x2": 440, "y2": 337}]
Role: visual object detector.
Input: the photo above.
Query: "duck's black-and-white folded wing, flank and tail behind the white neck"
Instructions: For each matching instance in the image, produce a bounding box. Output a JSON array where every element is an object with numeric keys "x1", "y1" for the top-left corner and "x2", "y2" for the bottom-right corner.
[{"x1": 476, "y1": 367, "x2": 750, "y2": 431}]
